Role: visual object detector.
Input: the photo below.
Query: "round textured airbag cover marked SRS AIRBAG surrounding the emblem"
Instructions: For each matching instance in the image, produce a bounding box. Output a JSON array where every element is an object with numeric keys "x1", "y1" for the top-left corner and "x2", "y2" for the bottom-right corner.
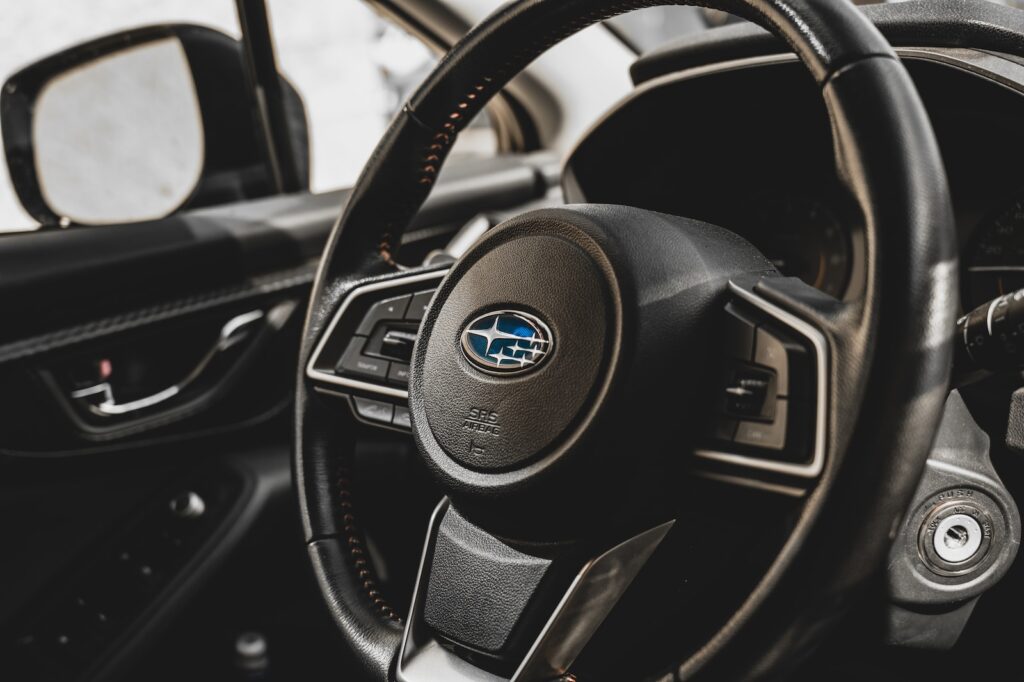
[{"x1": 421, "y1": 223, "x2": 609, "y2": 471}]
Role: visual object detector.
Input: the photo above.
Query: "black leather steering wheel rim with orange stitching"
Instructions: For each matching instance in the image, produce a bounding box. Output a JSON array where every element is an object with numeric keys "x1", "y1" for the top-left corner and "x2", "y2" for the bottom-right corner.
[{"x1": 295, "y1": 0, "x2": 957, "y2": 679}]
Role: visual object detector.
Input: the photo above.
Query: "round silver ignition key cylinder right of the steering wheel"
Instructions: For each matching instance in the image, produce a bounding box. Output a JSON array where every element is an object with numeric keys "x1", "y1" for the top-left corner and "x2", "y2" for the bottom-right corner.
[{"x1": 918, "y1": 500, "x2": 993, "y2": 577}]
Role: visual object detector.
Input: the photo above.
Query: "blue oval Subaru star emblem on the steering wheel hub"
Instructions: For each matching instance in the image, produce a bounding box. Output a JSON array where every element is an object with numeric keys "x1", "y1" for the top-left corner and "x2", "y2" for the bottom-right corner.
[{"x1": 462, "y1": 310, "x2": 554, "y2": 374}]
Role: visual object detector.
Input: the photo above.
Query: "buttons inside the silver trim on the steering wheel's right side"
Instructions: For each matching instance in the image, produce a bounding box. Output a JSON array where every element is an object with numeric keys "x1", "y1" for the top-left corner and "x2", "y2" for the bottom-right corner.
[{"x1": 702, "y1": 301, "x2": 816, "y2": 465}]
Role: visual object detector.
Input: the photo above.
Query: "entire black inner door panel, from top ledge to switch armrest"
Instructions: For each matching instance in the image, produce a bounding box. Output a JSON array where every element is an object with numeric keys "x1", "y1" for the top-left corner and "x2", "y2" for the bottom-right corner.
[{"x1": 0, "y1": 152, "x2": 557, "y2": 680}]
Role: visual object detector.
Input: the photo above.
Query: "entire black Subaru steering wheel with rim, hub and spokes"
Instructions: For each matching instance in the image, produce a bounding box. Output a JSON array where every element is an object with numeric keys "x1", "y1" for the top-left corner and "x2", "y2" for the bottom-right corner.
[{"x1": 295, "y1": 0, "x2": 957, "y2": 682}]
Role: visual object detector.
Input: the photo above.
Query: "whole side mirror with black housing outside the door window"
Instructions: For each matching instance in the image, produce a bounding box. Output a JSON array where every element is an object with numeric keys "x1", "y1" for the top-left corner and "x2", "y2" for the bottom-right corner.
[{"x1": 0, "y1": 25, "x2": 309, "y2": 226}]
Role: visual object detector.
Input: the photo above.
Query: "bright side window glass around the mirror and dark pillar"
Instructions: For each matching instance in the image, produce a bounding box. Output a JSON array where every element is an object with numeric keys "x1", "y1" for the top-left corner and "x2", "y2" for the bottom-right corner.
[{"x1": 0, "y1": 0, "x2": 498, "y2": 231}]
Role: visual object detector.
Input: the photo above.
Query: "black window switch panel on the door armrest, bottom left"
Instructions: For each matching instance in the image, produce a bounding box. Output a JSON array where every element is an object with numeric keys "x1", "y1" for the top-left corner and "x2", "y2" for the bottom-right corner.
[{"x1": 0, "y1": 469, "x2": 244, "y2": 682}]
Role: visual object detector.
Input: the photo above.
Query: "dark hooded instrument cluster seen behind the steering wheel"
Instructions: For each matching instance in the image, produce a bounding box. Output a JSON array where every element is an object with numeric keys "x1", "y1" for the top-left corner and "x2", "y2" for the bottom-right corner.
[{"x1": 563, "y1": 49, "x2": 1024, "y2": 310}]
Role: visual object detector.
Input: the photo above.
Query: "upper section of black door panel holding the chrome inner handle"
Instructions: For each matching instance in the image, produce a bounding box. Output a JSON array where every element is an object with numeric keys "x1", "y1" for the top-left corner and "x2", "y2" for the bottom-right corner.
[{"x1": 0, "y1": 157, "x2": 551, "y2": 456}]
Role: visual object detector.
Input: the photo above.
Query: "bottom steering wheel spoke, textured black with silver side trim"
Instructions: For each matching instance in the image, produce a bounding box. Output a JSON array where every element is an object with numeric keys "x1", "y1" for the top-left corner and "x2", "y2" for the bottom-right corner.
[{"x1": 396, "y1": 499, "x2": 674, "y2": 682}]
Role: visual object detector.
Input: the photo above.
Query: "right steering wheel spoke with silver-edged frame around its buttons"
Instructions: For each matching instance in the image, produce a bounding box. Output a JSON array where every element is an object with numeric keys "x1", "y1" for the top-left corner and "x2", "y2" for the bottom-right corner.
[{"x1": 694, "y1": 278, "x2": 843, "y2": 497}]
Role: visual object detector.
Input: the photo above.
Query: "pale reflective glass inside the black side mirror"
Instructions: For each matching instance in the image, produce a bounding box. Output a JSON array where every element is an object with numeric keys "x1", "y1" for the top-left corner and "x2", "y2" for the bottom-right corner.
[{"x1": 32, "y1": 38, "x2": 205, "y2": 224}]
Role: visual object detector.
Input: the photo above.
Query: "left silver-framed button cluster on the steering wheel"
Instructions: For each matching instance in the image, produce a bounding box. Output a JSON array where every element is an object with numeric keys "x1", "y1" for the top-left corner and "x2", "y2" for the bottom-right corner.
[{"x1": 306, "y1": 270, "x2": 446, "y2": 431}]
